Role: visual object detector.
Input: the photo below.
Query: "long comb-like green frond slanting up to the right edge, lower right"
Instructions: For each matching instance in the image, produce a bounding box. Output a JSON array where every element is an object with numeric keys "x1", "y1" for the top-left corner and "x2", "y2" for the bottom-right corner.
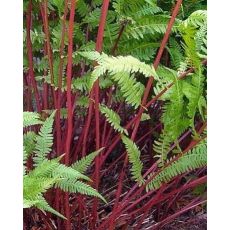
[{"x1": 146, "y1": 139, "x2": 207, "y2": 191}]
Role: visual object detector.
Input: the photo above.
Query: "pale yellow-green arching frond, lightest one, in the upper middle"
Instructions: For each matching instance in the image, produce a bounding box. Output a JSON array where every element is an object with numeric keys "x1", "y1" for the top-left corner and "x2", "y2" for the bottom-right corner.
[{"x1": 79, "y1": 52, "x2": 157, "y2": 108}]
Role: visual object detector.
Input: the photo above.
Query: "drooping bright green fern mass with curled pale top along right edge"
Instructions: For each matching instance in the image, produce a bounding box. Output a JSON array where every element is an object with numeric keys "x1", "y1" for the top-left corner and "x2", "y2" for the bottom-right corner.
[{"x1": 153, "y1": 11, "x2": 206, "y2": 165}]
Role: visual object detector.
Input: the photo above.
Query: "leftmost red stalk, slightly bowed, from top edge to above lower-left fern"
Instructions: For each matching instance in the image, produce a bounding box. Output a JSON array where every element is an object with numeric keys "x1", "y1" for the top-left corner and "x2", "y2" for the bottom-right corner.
[{"x1": 26, "y1": 0, "x2": 41, "y2": 113}]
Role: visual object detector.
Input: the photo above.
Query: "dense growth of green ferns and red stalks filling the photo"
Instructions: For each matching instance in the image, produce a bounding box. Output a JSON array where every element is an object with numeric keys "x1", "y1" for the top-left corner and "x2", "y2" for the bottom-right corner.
[{"x1": 23, "y1": 0, "x2": 207, "y2": 230}]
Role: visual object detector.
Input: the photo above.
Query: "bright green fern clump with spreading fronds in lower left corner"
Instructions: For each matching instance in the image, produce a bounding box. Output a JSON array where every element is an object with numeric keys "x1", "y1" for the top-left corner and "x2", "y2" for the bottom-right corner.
[{"x1": 23, "y1": 111, "x2": 106, "y2": 218}]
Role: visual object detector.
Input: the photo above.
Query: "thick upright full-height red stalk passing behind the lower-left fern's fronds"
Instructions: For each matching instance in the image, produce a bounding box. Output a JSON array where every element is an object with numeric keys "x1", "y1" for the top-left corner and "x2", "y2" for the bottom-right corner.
[{"x1": 65, "y1": 0, "x2": 76, "y2": 230}]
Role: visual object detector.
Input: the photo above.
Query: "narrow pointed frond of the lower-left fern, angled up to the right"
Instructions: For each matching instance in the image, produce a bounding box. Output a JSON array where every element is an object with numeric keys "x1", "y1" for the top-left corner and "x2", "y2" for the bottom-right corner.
[{"x1": 71, "y1": 148, "x2": 104, "y2": 173}]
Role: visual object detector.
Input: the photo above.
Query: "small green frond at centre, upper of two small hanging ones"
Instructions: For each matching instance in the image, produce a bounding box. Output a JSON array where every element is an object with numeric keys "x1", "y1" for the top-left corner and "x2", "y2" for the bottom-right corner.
[{"x1": 100, "y1": 105, "x2": 128, "y2": 135}]
